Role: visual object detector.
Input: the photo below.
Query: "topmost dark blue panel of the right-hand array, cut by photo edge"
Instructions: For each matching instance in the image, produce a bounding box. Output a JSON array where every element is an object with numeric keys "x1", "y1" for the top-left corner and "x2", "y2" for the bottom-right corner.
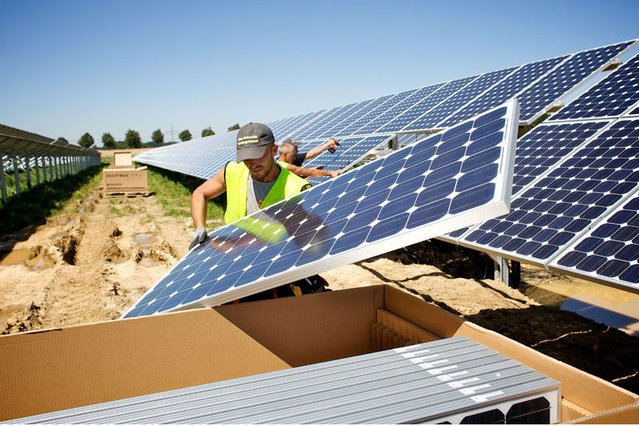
[{"x1": 550, "y1": 54, "x2": 639, "y2": 121}]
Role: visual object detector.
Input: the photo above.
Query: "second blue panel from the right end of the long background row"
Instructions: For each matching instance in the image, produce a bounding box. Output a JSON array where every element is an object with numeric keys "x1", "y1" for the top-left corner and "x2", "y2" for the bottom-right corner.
[{"x1": 438, "y1": 56, "x2": 567, "y2": 127}]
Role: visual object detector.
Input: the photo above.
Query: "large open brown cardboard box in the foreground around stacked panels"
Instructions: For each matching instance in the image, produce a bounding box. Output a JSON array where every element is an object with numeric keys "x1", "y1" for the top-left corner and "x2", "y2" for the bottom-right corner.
[{"x1": 0, "y1": 286, "x2": 639, "y2": 423}]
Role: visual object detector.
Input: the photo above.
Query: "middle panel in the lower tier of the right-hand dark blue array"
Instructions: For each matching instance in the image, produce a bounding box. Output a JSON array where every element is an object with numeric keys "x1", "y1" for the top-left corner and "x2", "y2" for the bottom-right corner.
[{"x1": 460, "y1": 116, "x2": 639, "y2": 263}]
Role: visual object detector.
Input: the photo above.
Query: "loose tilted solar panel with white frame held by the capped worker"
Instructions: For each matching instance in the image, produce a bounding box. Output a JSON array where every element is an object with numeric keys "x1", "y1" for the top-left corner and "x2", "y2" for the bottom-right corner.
[{"x1": 124, "y1": 101, "x2": 518, "y2": 318}]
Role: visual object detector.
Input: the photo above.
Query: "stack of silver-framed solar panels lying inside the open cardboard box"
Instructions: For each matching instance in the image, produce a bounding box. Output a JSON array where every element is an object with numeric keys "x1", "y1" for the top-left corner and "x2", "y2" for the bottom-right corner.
[{"x1": 9, "y1": 337, "x2": 561, "y2": 424}]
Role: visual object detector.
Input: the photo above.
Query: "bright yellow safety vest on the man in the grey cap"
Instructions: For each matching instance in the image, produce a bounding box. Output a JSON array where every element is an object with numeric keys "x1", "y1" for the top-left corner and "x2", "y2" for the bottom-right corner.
[{"x1": 224, "y1": 161, "x2": 309, "y2": 224}]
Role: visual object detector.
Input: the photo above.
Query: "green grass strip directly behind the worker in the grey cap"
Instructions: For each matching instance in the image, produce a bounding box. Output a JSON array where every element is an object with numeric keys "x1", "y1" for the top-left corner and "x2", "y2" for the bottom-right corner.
[{"x1": 148, "y1": 167, "x2": 225, "y2": 228}]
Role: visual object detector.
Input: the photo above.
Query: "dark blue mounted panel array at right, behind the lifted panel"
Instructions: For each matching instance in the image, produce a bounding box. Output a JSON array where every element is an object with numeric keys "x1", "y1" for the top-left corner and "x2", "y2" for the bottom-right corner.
[{"x1": 445, "y1": 48, "x2": 639, "y2": 291}]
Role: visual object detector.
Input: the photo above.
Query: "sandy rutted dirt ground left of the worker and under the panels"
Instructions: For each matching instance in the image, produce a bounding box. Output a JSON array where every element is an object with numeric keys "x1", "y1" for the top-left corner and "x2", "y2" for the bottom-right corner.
[{"x1": 0, "y1": 187, "x2": 639, "y2": 393}]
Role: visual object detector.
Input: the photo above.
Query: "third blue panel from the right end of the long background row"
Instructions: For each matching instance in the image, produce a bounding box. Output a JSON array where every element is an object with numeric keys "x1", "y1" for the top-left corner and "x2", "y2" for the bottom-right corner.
[{"x1": 404, "y1": 67, "x2": 517, "y2": 131}]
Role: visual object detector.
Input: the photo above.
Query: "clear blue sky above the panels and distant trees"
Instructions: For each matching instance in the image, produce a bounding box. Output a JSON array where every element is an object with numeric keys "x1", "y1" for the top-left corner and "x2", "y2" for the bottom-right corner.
[{"x1": 0, "y1": 0, "x2": 639, "y2": 146}]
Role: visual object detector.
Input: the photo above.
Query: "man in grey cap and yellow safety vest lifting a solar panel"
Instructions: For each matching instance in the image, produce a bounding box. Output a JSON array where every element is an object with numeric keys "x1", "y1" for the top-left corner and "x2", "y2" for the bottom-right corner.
[{"x1": 189, "y1": 123, "x2": 327, "y2": 301}]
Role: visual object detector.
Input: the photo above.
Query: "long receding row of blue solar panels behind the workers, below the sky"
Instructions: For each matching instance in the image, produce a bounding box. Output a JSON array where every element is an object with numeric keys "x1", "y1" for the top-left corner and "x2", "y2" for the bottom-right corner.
[{"x1": 135, "y1": 40, "x2": 634, "y2": 183}]
